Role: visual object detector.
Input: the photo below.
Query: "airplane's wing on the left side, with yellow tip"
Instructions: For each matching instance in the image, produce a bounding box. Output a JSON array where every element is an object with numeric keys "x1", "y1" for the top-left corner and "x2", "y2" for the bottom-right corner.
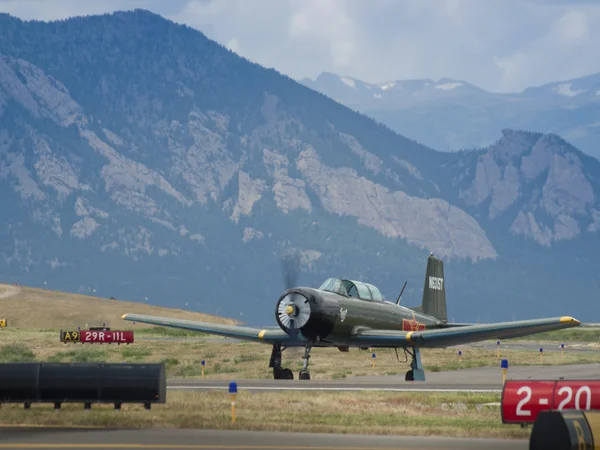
[{"x1": 121, "y1": 314, "x2": 301, "y2": 344}]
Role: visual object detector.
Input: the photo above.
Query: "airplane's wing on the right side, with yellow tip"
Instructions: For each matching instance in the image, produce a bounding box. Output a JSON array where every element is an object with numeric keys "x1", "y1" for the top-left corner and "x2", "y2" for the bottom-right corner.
[{"x1": 351, "y1": 316, "x2": 581, "y2": 348}]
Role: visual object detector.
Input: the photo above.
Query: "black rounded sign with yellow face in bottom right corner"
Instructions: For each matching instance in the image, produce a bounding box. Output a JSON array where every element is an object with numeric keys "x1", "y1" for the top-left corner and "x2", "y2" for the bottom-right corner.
[{"x1": 529, "y1": 410, "x2": 600, "y2": 450}]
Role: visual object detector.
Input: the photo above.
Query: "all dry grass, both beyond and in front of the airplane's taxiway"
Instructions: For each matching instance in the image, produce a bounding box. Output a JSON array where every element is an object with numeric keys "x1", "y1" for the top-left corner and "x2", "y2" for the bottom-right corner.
[{"x1": 0, "y1": 285, "x2": 600, "y2": 438}]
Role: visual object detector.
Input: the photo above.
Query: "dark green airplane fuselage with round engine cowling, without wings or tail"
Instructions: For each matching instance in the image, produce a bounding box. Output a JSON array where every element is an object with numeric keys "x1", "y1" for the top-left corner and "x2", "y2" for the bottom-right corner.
[{"x1": 276, "y1": 287, "x2": 443, "y2": 346}]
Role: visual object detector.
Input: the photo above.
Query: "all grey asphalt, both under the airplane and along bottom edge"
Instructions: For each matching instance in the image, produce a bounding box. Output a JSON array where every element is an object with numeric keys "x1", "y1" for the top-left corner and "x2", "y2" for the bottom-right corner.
[{"x1": 0, "y1": 364, "x2": 600, "y2": 450}]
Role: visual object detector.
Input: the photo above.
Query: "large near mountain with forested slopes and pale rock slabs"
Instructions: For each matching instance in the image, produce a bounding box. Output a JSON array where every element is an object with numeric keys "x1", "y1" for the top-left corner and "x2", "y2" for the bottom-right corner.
[{"x1": 0, "y1": 10, "x2": 600, "y2": 324}]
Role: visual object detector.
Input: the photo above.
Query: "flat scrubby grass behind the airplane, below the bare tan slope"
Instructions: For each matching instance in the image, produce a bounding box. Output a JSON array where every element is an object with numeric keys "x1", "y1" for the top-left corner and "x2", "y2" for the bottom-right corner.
[{"x1": 0, "y1": 328, "x2": 600, "y2": 380}]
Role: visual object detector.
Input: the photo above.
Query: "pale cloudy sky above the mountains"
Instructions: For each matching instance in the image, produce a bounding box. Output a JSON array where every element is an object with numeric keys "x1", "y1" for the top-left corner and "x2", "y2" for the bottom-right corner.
[{"x1": 0, "y1": 0, "x2": 600, "y2": 92}]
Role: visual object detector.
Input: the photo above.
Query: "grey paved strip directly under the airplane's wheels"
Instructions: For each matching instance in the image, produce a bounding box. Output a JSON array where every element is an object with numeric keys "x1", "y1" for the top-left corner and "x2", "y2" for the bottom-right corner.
[{"x1": 167, "y1": 364, "x2": 600, "y2": 392}]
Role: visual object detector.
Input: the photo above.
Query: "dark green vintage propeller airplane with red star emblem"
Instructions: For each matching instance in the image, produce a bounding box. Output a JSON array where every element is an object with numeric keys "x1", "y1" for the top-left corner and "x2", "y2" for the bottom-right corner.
[{"x1": 123, "y1": 255, "x2": 580, "y2": 381}]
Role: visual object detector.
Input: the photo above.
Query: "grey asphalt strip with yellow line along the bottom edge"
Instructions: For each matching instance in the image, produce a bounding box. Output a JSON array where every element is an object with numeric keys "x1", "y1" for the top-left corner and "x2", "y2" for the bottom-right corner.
[{"x1": 0, "y1": 428, "x2": 529, "y2": 450}]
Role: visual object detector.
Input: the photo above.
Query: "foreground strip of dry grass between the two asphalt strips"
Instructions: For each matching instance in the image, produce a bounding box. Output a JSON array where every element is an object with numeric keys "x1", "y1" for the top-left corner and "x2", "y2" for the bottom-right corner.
[{"x1": 0, "y1": 391, "x2": 530, "y2": 439}]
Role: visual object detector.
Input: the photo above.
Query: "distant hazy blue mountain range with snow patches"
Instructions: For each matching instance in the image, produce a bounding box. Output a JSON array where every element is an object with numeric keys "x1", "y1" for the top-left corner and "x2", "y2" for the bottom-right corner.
[{"x1": 301, "y1": 73, "x2": 600, "y2": 158}]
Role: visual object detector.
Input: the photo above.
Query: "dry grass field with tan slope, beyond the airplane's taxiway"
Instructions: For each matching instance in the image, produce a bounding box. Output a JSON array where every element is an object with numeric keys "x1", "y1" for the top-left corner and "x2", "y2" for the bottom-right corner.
[{"x1": 0, "y1": 285, "x2": 600, "y2": 380}]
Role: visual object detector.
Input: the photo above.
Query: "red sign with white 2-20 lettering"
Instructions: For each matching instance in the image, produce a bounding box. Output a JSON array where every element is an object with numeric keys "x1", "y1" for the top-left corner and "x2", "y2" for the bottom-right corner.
[{"x1": 501, "y1": 380, "x2": 600, "y2": 423}]
